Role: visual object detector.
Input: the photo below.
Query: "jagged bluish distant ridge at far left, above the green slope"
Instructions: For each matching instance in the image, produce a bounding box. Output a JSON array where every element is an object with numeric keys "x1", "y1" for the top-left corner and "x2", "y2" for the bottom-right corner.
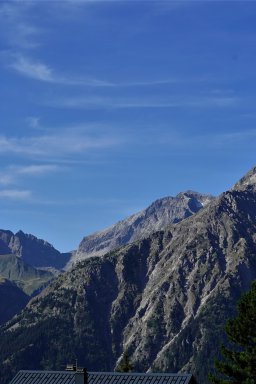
[{"x1": 0, "y1": 230, "x2": 71, "y2": 269}]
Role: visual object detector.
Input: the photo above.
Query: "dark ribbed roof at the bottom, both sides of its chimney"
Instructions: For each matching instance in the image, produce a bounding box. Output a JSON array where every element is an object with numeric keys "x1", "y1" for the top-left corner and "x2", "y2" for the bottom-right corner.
[{"x1": 10, "y1": 371, "x2": 192, "y2": 384}]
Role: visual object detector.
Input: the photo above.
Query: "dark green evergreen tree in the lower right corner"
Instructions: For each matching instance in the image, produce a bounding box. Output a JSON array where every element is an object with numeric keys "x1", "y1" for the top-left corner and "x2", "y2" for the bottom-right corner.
[{"x1": 209, "y1": 282, "x2": 256, "y2": 384}]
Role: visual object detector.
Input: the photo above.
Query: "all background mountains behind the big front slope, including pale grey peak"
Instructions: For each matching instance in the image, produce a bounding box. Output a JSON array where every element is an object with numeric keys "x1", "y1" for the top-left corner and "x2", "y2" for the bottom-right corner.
[{"x1": 0, "y1": 191, "x2": 213, "y2": 324}]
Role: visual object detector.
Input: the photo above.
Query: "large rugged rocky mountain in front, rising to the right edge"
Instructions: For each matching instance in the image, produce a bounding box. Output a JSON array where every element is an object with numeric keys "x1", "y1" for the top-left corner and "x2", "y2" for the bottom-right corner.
[{"x1": 0, "y1": 168, "x2": 256, "y2": 384}]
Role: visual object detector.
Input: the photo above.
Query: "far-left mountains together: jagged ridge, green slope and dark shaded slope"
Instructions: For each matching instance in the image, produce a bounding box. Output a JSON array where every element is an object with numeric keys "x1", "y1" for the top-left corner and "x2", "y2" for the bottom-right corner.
[{"x1": 0, "y1": 230, "x2": 67, "y2": 324}]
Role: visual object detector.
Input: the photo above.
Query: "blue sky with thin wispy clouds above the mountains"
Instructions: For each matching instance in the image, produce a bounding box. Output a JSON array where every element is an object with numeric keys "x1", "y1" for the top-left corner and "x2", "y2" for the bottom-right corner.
[{"x1": 0, "y1": 0, "x2": 256, "y2": 252}]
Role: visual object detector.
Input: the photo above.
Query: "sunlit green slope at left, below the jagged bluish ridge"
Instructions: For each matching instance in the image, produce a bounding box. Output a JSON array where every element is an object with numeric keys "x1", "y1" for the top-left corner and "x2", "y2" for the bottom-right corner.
[{"x1": 0, "y1": 255, "x2": 55, "y2": 296}]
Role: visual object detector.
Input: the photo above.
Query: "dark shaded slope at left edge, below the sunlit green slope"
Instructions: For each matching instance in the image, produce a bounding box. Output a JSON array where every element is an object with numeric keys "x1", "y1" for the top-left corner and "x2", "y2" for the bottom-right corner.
[{"x1": 0, "y1": 276, "x2": 29, "y2": 324}]
